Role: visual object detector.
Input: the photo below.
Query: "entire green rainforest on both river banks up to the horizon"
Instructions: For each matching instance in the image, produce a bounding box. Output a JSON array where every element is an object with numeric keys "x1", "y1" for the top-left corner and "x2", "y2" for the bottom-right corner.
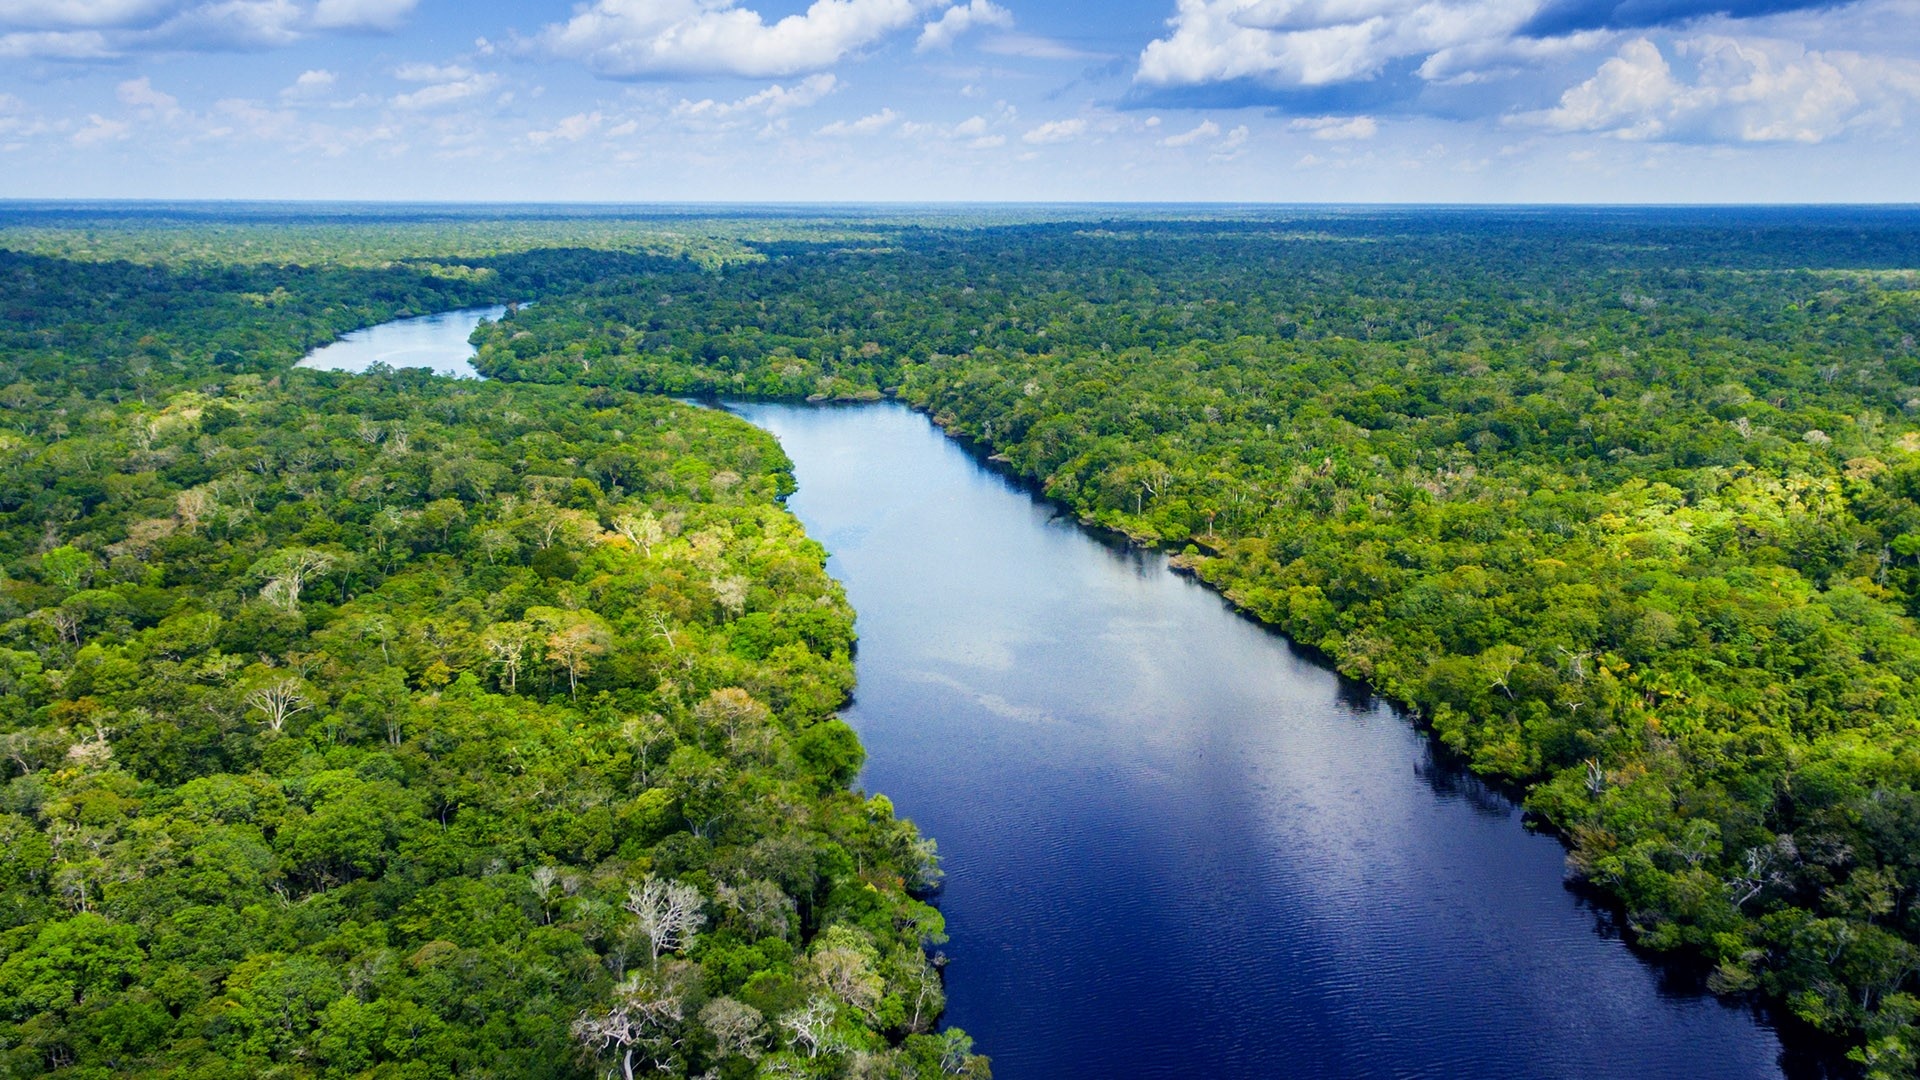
[{"x1": 0, "y1": 204, "x2": 1920, "y2": 1078}]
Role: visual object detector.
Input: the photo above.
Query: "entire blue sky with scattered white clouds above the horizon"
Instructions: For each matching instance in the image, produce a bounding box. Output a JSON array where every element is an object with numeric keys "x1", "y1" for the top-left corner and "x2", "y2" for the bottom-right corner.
[{"x1": 0, "y1": 0, "x2": 1920, "y2": 204}]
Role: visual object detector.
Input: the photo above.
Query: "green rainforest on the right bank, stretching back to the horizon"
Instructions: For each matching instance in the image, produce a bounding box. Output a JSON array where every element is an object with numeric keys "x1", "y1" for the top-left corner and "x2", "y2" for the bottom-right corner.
[{"x1": 456, "y1": 208, "x2": 1920, "y2": 1074}]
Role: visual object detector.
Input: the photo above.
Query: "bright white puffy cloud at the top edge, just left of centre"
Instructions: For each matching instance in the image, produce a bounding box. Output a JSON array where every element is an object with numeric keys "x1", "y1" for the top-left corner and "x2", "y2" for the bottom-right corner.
[{"x1": 540, "y1": 0, "x2": 944, "y2": 79}]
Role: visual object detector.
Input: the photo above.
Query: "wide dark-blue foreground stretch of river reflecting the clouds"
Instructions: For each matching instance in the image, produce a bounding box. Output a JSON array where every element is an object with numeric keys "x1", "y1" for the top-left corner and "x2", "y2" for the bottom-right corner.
[{"x1": 730, "y1": 404, "x2": 1801, "y2": 1080}]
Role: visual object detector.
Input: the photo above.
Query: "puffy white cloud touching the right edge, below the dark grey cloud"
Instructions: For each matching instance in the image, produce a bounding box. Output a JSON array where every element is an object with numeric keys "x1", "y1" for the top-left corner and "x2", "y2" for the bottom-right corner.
[{"x1": 1513, "y1": 35, "x2": 1920, "y2": 142}]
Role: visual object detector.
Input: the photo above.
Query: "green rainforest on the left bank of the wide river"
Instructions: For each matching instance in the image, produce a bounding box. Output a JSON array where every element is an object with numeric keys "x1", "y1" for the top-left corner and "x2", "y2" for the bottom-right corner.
[{"x1": 0, "y1": 214, "x2": 985, "y2": 1078}]
